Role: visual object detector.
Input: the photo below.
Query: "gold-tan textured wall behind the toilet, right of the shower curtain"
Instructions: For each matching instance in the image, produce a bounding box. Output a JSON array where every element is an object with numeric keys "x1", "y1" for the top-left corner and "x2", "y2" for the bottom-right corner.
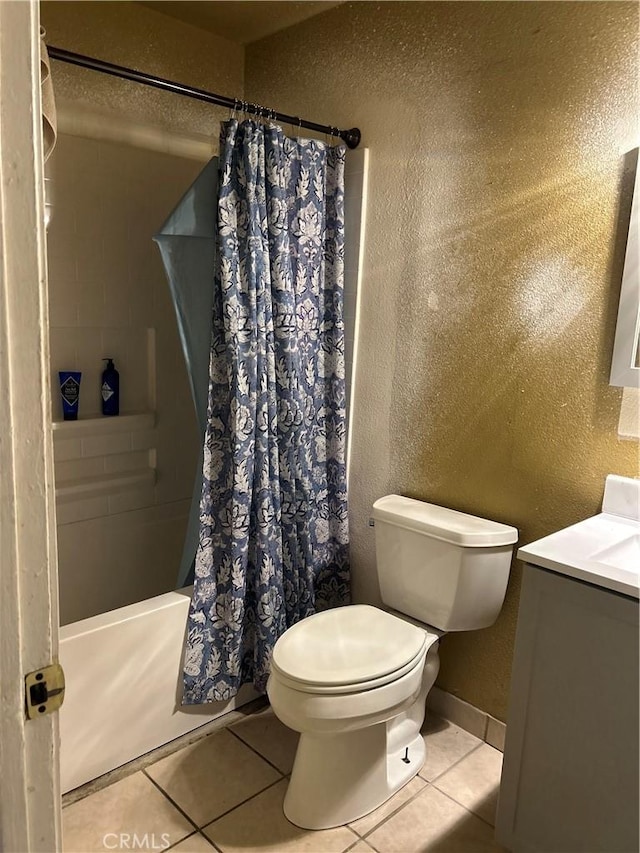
[{"x1": 245, "y1": 2, "x2": 638, "y2": 719}]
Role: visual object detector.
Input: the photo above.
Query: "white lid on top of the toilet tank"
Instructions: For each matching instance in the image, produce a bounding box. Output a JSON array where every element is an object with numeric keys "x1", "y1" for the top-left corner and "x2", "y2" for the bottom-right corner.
[{"x1": 373, "y1": 495, "x2": 518, "y2": 548}]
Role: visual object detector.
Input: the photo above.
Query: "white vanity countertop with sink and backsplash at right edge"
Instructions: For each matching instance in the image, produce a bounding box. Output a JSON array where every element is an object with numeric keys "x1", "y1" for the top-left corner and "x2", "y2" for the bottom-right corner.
[{"x1": 518, "y1": 476, "x2": 640, "y2": 598}]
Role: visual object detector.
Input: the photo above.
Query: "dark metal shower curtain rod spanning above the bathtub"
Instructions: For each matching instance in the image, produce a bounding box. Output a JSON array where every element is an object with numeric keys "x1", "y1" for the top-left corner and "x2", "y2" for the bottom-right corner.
[{"x1": 47, "y1": 45, "x2": 360, "y2": 148}]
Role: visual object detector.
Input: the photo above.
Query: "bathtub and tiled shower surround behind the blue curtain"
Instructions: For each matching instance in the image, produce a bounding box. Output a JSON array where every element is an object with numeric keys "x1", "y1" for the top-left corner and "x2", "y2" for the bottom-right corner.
[{"x1": 48, "y1": 96, "x2": 367, "y2": 791}]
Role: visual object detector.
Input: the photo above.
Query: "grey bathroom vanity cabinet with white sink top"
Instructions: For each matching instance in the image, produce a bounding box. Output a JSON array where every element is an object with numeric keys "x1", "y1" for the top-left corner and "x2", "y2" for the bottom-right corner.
[{"x1": 496, "y1": 477, "x2": 640, "y2": 853}]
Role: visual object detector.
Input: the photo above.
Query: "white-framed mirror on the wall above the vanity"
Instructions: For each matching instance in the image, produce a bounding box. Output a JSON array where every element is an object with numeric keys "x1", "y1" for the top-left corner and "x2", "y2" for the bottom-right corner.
[{"x1": 609, "y1": 154, "x2": 640, "y2": 388}]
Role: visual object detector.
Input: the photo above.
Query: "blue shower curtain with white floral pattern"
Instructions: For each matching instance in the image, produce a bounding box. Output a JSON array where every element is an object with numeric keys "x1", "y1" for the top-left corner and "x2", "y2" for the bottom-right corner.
[{"x1": 183, "y1": 120, "x2": 349, "y2": 704}]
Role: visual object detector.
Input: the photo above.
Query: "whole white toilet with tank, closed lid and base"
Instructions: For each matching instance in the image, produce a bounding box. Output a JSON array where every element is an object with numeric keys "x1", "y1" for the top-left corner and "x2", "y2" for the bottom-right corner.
[{"x1": 267, "y1": 495, "x2": 518, "y2": 829}]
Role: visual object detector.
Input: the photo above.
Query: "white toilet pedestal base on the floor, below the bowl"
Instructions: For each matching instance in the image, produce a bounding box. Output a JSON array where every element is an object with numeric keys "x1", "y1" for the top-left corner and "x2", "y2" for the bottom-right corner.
[{"x1": 284, "y1": 720, "x2": 425, "y2": 829}]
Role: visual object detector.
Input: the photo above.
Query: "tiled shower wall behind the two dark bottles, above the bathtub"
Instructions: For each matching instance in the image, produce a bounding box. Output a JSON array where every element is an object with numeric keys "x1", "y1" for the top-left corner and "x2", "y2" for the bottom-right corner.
[{"x1": 47, "y1": 128, "x2": 203, "y2": 622}]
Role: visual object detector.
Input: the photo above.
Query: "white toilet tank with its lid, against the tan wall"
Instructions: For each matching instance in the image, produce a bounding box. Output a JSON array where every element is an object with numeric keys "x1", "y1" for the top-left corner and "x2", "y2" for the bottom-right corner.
[{"x1": 373, "y1": 495, "x2": 518, "y2": 631}]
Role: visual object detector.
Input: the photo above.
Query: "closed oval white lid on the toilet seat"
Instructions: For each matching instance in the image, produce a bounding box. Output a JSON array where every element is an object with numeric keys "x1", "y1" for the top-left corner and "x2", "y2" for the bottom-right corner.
[{"x1": 271, "y1": 604, "x2": 427, "y2": 687}]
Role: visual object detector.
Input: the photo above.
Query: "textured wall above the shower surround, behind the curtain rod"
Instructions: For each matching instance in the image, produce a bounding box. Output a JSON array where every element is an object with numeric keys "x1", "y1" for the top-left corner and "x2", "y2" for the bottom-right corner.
[{"x1": 40, "y1": 0, "x2": 244, "y2": 139}]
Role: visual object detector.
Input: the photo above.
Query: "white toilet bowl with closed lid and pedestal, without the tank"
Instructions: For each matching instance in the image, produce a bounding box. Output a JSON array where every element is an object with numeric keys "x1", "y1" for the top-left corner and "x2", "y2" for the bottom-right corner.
[{"x1": 267, "y1": 605, "x2": 439, "y2": 829}]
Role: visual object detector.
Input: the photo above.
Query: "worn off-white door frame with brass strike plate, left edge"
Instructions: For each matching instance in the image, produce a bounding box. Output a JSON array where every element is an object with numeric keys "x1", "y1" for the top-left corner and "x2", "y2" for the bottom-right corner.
[{"x1": 0, "y1": 0, "x2": 61, "y2": 853}]
